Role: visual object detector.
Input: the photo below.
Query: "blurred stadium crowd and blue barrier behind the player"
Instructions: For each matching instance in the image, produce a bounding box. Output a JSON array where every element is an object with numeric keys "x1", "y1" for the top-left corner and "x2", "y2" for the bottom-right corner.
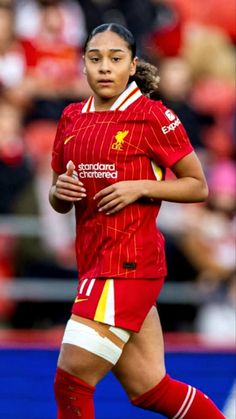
[{"x1": 0, "y1": 0, "x2": 236, "y2": 419}]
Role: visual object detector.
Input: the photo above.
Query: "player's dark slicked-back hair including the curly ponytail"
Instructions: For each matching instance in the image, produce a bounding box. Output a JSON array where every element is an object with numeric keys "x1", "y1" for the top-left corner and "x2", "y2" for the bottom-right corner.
[{"x1": 84, "y1": 23, "x2": 159, "y2": 97}]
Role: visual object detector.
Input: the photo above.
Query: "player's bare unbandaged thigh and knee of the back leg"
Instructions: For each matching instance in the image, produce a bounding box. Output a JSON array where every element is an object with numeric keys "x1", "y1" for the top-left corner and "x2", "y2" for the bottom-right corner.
[{"x1": 113, "y1": 307, "x2": 165, "y2": 399}]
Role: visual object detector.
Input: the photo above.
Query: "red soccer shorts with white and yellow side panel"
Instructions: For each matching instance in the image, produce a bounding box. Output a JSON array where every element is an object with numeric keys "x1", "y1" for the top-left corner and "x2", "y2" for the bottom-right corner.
[{"x1": 72, "y1": 278, "x2": 164, "y2": 332}]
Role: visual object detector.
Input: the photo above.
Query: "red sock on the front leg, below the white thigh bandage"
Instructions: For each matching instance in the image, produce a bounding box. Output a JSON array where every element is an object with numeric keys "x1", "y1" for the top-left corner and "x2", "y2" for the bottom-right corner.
[{"x1": 54, "y1": 368, "x2": 95, "y2": 419}]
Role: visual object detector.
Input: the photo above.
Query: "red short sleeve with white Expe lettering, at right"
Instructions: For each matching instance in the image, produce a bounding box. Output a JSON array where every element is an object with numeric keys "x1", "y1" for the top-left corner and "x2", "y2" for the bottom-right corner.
[{"x1": 146, "y1": 101, "x2": 193, "y2": 167}]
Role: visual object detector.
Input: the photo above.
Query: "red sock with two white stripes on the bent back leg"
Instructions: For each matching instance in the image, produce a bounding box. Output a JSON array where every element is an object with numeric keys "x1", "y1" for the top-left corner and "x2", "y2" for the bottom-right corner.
[{"x1": 132, "y1": 375, "x2": 224, "y2": 419}]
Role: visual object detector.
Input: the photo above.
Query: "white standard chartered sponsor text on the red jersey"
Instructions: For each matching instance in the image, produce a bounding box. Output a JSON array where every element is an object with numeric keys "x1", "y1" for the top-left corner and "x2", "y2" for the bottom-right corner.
[{"x1": 78, "y1": 162, "x2": 118, "y2": 179}]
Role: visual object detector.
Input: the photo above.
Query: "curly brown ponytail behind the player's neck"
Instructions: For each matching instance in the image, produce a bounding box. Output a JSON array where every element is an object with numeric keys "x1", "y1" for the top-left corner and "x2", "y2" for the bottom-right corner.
[{"x1": 129, "y1": 60, "x2": 160, "y2": 97}]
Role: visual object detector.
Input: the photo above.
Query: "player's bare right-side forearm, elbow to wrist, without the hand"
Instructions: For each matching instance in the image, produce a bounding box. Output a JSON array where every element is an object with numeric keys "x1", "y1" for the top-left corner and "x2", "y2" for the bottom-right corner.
[{"x1": 142, "y1": 177, "x2": 208, "y2": 203}]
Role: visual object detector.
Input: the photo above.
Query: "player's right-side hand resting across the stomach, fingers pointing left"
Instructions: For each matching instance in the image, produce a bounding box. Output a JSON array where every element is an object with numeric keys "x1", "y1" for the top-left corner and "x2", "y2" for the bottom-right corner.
[{"x1": 94, "y1": 180, "x2": 142, "y2": 215}]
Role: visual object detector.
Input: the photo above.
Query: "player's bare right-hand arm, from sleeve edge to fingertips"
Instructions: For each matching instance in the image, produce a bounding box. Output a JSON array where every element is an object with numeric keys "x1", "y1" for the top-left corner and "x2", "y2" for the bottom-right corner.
[{"x1": 94, "y1": 152, "x2": 208, "y2": 214}]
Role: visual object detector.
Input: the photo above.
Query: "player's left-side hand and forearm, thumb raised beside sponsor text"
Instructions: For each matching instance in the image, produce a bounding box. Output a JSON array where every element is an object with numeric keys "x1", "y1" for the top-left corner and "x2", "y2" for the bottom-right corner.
[{"x1": 49, "y1": 161, "x2": 86, "y2": 214}]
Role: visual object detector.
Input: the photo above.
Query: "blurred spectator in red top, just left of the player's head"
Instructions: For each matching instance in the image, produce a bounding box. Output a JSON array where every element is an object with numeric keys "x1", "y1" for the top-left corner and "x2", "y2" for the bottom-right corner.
[{"x1": 16, "y1": 1, "x2": 90, "y2": 120}]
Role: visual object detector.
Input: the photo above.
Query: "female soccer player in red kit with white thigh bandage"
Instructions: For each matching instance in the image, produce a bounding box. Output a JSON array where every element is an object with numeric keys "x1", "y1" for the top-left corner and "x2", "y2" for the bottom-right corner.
[{"x1": 50, "y1": 24, "x2": 223, "y2": 419}]
